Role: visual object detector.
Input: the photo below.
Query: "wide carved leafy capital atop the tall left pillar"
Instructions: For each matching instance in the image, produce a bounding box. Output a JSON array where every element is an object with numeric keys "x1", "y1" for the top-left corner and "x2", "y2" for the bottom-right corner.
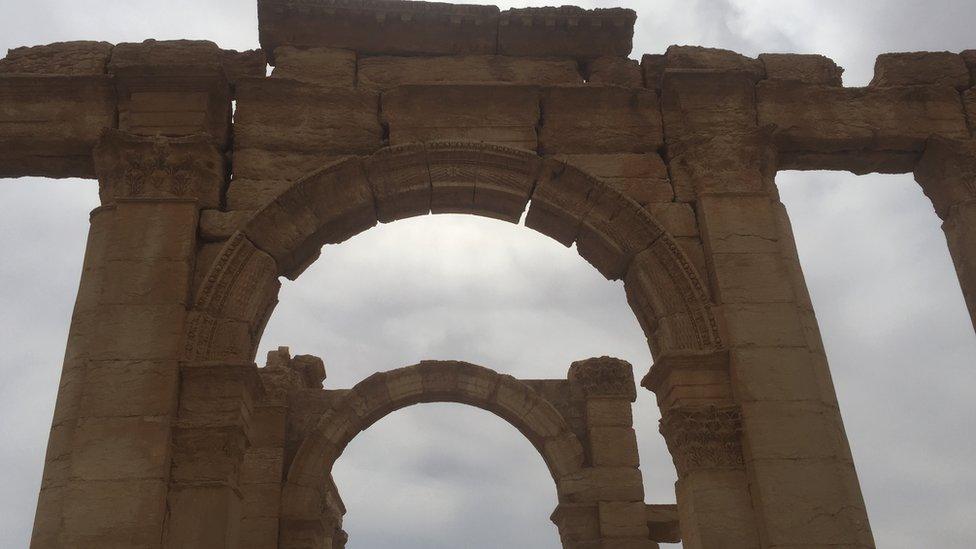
[{"x1": 95, "y1": 130, "x2": 226, "y2": 208}]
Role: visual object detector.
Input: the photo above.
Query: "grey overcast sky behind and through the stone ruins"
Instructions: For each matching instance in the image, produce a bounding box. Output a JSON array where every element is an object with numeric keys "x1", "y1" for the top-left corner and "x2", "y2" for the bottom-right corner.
[{"x1": 0, "y1": 0, "x2": 976, "y2": 549}]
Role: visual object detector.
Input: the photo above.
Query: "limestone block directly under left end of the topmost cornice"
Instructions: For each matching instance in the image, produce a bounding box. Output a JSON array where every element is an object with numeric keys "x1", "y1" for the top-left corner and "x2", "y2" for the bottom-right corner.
[{"x1": 271, "y1": 46, "x2": 356, "y2": 88}]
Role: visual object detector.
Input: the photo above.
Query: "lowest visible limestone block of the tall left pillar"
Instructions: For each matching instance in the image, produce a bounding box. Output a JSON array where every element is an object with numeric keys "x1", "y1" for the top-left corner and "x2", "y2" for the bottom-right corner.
[{"x1": 60, "y1": 479, "x2": 167, "y2": 547}]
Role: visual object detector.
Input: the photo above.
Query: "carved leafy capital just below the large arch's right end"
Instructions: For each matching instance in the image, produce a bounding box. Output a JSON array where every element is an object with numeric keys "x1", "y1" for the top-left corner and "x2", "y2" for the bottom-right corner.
[{"x1": 660, "y1": 406, "x2": 744, "y2": 477}]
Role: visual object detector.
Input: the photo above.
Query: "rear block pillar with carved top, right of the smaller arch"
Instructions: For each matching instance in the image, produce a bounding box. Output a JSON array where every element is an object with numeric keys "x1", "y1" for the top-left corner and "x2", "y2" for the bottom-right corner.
[{"x1": 552, "y1": 357, "x2": 657, "y2": 549}]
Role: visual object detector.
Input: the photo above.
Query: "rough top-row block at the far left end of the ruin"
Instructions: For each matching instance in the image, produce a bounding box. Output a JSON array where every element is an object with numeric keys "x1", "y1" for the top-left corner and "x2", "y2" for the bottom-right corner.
[{"x1": 0, "y1": 41, "x2": 113, "y2": 76}]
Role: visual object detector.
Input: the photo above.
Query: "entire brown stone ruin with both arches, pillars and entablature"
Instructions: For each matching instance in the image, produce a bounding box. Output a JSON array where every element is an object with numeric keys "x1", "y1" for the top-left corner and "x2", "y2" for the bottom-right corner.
[{"x1": 0, "y1": 0, "x2": 976, "y2": 549}]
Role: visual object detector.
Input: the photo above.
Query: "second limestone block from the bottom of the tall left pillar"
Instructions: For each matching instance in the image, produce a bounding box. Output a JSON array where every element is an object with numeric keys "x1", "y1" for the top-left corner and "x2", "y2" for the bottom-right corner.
[{"x1": 71, "y1": 416, "x2": 171, "y2": 481}]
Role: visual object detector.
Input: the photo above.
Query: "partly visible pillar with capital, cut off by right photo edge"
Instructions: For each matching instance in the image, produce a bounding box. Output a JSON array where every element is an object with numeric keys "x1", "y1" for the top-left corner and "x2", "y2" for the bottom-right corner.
[{"x1": 915, "y1": 138, "x2": 976, "y2": 328}]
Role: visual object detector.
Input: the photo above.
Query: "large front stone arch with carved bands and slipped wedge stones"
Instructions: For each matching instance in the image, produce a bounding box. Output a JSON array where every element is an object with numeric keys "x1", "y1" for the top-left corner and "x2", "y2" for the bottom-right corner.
[{"x1": 185, "y1": 142, "x2": 722, "y2": 360}]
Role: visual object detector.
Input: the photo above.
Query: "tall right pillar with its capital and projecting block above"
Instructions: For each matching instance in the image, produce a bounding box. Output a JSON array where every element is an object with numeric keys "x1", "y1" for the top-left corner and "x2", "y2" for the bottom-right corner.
[{"x1": 662, "y1": 69, "x2": 874, "y2": 548}]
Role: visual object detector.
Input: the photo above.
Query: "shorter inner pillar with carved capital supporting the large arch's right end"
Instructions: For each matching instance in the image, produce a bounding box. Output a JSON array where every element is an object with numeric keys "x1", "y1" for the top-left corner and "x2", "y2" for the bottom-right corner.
[{"x1": 641, "y1": 351, "x2": 760, "y2": 549}]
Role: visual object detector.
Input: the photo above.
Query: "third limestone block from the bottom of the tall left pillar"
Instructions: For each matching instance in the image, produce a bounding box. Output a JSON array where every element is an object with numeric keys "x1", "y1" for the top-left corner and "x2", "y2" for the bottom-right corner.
[{"x1": 79, "y1": 360, "x2": 178, "y2": 417}]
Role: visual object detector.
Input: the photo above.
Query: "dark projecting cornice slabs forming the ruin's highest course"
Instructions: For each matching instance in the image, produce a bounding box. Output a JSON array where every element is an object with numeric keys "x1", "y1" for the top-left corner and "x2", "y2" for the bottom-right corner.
[{"x1": 258, "y1": 0, "x2": 637, "y2": 61}]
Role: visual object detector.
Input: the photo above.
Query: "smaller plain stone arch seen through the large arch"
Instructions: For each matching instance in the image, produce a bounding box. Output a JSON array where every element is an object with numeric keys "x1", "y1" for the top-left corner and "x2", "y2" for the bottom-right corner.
[{"x1": 279, "y1": 361, "x2": 585, "y2": 548}]
